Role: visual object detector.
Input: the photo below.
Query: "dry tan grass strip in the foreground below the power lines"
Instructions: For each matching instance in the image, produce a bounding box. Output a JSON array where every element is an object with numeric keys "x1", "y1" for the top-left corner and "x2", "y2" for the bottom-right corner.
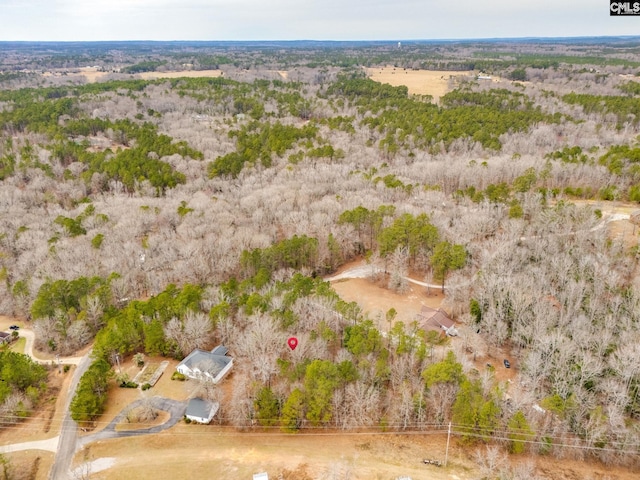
[{"x1": 72, "y1": 423, "x2": 637, "y2": 480}]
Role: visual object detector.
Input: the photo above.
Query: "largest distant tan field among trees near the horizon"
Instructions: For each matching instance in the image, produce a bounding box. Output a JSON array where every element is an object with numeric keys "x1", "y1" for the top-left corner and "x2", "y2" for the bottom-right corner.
[{"x1": 366, "y1": 67, "x2": 473, "y2": 103}]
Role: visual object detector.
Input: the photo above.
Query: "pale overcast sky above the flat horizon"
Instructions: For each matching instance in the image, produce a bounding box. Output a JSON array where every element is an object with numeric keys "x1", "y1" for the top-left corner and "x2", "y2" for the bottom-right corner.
[{"x1": 0, "y1": 0, "x2": 640, "y2": 41}]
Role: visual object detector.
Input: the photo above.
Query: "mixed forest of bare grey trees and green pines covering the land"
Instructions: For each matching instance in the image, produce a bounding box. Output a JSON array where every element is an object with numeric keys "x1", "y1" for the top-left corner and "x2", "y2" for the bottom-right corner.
[{"x1": 0, "y1": 40, "x2": 640, "y2": 472}]
